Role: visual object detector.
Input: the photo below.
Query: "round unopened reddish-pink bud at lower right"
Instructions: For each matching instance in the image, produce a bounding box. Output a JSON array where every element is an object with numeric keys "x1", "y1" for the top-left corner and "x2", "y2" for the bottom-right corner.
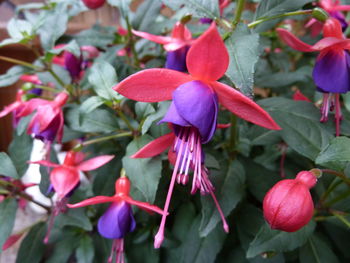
[{"x1": 263, "y1": 171, "x2": 317, "y2": 232}]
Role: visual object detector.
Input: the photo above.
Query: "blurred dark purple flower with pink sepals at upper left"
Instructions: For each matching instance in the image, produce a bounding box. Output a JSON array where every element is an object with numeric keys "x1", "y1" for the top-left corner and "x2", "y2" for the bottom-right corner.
[{"x1": 53, "y1": 45, "x2": 99, "y2": 81}]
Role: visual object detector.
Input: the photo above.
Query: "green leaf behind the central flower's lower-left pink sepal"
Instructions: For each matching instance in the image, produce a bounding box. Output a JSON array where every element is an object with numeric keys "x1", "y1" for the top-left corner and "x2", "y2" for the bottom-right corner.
[{"x1": 122, "y1": 135, "x2": 162, "y2": 203}]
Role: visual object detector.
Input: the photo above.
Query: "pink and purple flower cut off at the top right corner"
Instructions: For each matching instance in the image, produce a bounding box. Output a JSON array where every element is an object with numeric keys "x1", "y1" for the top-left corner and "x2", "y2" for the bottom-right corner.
[{"x1": 306, "y1": 0, "x2": 350, "y2": 37}]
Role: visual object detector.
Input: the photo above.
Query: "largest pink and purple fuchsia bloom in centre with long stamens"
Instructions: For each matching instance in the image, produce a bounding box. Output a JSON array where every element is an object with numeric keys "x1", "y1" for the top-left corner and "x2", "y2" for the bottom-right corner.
[{"x1": 114, "y1": 23, "x2": 280, "y2": 248}]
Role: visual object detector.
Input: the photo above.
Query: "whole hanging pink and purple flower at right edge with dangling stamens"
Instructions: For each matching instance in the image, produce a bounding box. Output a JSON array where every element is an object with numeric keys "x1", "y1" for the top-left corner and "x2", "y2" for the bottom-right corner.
[{"x1": 277, "y1": 18, "x2": 350, "y2": 136}]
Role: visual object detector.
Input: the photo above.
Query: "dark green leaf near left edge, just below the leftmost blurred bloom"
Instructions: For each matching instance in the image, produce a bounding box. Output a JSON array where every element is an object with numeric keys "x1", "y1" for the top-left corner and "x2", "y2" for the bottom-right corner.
[{"x1": 9, "y1": 133, "x2": 33, "y2": 177}]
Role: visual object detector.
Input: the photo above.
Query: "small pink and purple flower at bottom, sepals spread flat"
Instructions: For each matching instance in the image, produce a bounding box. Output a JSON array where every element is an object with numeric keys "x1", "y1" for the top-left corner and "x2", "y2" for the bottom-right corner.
[{"x1": 68, "y1": 176, "x2": 163, "y2": 263}]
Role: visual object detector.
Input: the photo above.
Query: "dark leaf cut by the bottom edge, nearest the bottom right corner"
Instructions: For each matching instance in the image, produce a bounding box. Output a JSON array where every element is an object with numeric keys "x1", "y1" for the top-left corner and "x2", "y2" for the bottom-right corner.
[{"x1": 299, "y1": 235, "x2": 339, "y2": 263}]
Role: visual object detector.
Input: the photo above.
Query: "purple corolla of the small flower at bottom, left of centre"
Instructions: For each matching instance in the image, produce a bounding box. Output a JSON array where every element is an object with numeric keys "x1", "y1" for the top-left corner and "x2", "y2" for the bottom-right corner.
[{"x1": 97, "y1": 201, "x2": 136, "y2": 239}]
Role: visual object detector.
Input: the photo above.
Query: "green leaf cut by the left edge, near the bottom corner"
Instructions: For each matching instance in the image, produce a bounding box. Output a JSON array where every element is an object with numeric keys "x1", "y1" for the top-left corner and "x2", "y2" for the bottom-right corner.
[{"x1": 0, "y1": 198, "x2": 17, "y2": 252}]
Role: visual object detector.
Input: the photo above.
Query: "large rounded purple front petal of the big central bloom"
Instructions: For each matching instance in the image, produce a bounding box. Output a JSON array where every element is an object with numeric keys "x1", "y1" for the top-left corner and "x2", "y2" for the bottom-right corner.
[{"x1": 173, "y1": 80, "x2": 218, "y2": 143}]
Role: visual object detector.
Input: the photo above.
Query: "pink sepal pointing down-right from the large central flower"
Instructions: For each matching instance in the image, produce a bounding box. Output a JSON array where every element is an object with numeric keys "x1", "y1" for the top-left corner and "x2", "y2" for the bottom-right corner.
[{"x1": 212, "y1": 82, "x2": 281, "y2": 130}]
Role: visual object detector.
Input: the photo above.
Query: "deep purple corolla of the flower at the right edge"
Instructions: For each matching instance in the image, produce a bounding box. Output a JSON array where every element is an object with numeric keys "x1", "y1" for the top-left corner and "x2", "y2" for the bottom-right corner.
[{"x1": 313, "y1": 50, "x2": 350, "y2": 93}]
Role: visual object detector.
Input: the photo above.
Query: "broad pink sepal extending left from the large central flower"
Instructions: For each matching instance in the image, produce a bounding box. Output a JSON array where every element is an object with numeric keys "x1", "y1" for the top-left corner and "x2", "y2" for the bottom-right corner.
[{"x1": 113, "y1": 68, "x2": 192, "y2": 102}]
